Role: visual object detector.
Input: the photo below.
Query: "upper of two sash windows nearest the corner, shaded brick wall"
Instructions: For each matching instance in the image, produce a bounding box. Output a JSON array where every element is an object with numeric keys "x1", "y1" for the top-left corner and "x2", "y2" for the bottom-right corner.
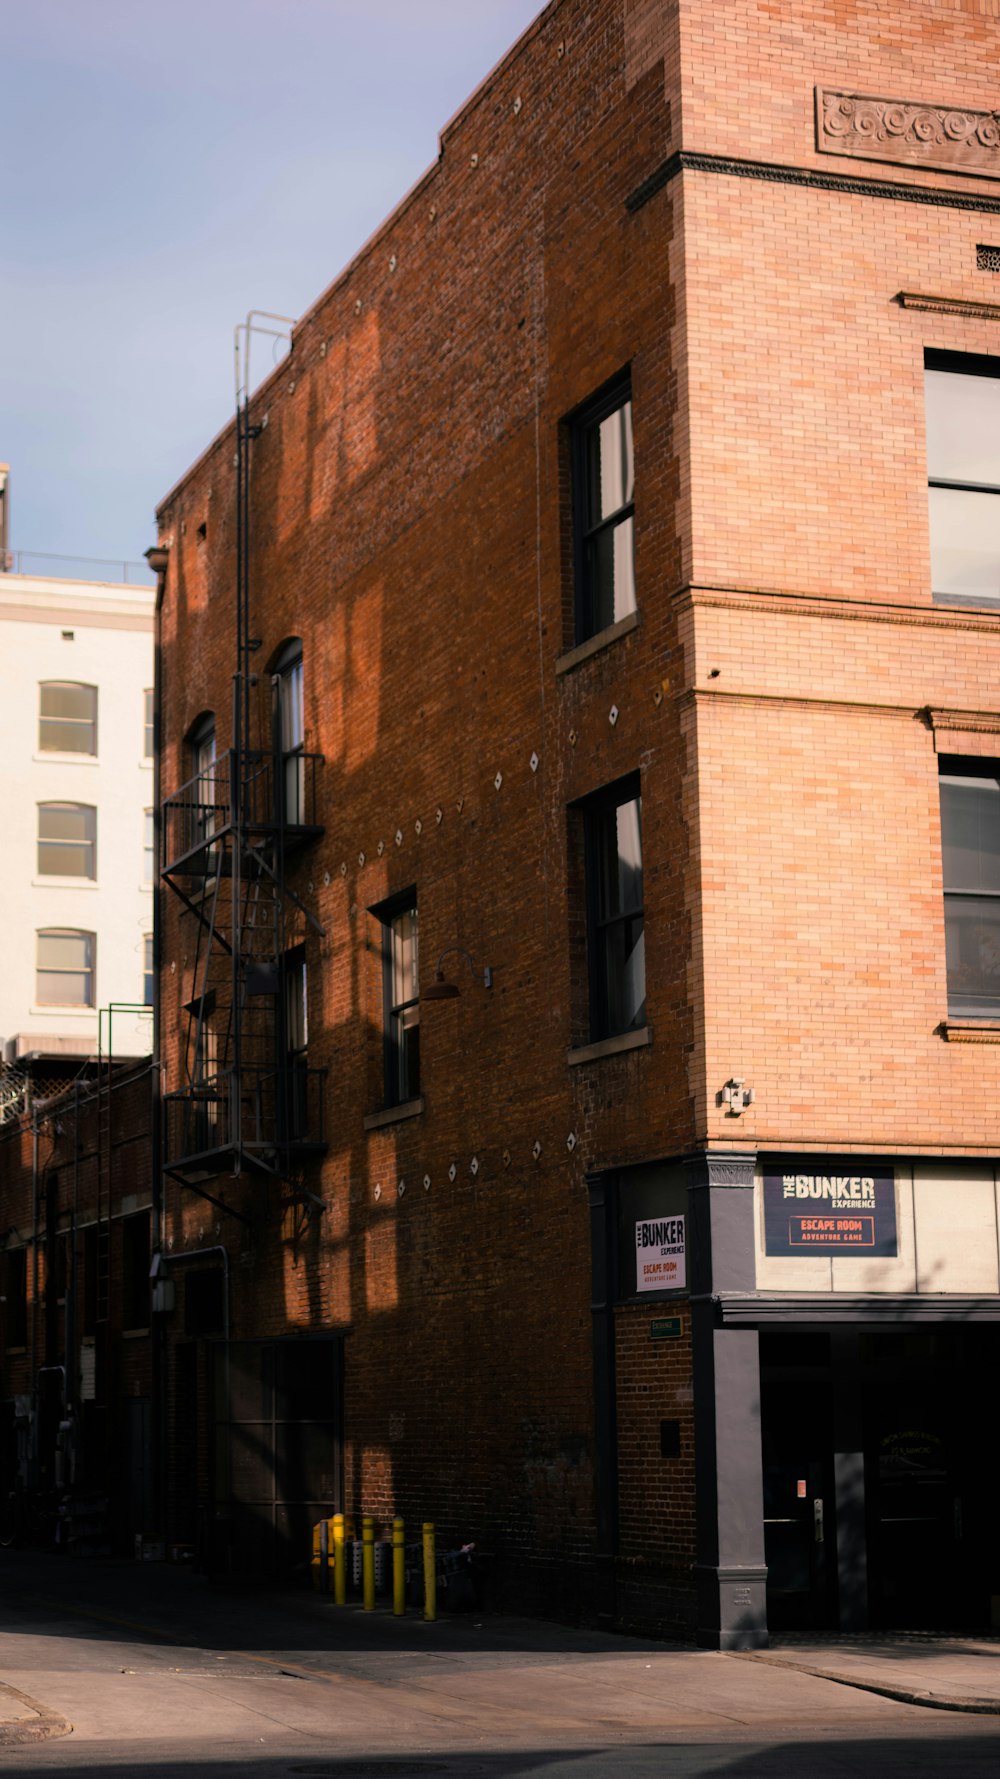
[{"x1": 571, "y1": 381, "x2": 635, "y2": 642}]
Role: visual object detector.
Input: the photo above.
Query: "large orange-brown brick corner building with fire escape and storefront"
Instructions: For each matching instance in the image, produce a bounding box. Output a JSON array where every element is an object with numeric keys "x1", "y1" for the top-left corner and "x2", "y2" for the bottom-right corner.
[{"x1": 147, "y1": 0, "x2": 1000, "y2": 1646}]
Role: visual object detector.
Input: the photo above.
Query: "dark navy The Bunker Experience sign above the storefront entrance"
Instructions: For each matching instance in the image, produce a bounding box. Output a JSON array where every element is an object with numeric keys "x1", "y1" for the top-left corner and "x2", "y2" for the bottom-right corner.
[{"x1": 763, "y1": 1160, "x2": 899, "y2": 1258}]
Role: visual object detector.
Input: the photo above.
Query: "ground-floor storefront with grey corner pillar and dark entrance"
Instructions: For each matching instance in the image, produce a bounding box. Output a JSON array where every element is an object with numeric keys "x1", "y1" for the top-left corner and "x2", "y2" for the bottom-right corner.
[{"x1": 591, "y1": 1151, "x2": 1000, "y2": 1647}]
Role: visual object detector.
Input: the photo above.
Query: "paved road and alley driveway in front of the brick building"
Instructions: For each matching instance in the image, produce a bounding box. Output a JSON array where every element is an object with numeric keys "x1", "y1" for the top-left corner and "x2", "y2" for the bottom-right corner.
[{"x1": 0, "y1": 1551, "x2": 1000, "y2": 1779}]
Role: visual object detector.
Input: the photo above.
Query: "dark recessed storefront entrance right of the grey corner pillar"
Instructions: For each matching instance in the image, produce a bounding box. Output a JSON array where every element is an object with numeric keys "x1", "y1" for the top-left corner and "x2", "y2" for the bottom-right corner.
[{"x1": 760, "y1": 1322, "x2": 1000, "y2": 1630}]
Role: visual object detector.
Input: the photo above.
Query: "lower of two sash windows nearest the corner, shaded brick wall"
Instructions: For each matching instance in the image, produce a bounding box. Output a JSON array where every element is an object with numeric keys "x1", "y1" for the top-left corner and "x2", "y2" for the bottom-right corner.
[{"x1": 584, "y1": 777, "x2": 646, "y2": 1041}]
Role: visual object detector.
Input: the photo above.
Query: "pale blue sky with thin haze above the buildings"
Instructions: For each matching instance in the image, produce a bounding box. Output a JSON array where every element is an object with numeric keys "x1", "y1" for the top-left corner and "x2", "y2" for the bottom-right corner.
[{"x1": 0, "y1": 0, "x2": 543, "y2": 573}]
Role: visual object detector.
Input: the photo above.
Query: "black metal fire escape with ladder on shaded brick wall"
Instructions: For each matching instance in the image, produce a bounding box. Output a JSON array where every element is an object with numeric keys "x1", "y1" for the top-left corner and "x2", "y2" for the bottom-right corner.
[{"x1": 160, "y1": 311, "x2": 326, "y2": 1210}]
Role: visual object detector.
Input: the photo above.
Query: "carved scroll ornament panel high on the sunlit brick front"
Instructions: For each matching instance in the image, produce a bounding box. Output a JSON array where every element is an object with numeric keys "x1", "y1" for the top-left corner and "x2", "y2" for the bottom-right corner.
[{"x1": 817, "y1": 87, "x2": 1000, "y2": 180}]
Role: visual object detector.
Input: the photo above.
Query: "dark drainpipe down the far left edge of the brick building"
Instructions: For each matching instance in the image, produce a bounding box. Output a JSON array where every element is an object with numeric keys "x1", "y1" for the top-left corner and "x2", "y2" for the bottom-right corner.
[{"x1": 146, "y1": 544, "x2": 169, "y2": 1537}]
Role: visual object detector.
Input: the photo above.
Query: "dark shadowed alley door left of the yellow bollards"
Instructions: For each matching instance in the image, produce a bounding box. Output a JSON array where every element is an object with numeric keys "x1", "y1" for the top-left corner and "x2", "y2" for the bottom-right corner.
[{"x1": 210, "y1": 1340, "x2": 342, "y2": 1576}]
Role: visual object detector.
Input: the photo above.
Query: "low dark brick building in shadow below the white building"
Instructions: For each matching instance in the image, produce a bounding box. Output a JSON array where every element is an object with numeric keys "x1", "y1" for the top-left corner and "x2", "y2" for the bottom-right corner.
[{"x1": 0, "y1": 1059, "x2": 160, "y2": 1555}]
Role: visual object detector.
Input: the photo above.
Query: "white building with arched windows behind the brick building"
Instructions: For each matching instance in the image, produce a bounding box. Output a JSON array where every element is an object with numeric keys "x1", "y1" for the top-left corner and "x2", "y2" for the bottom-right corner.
[{"x1": 0, "y1": 573, "x2": 155, "y2": 1062}]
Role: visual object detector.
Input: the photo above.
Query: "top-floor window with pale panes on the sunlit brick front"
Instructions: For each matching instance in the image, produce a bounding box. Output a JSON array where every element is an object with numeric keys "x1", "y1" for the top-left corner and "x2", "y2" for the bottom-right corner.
[{"x1": 923, "y1": 352, "x2": 1000, "y2": 605}]
